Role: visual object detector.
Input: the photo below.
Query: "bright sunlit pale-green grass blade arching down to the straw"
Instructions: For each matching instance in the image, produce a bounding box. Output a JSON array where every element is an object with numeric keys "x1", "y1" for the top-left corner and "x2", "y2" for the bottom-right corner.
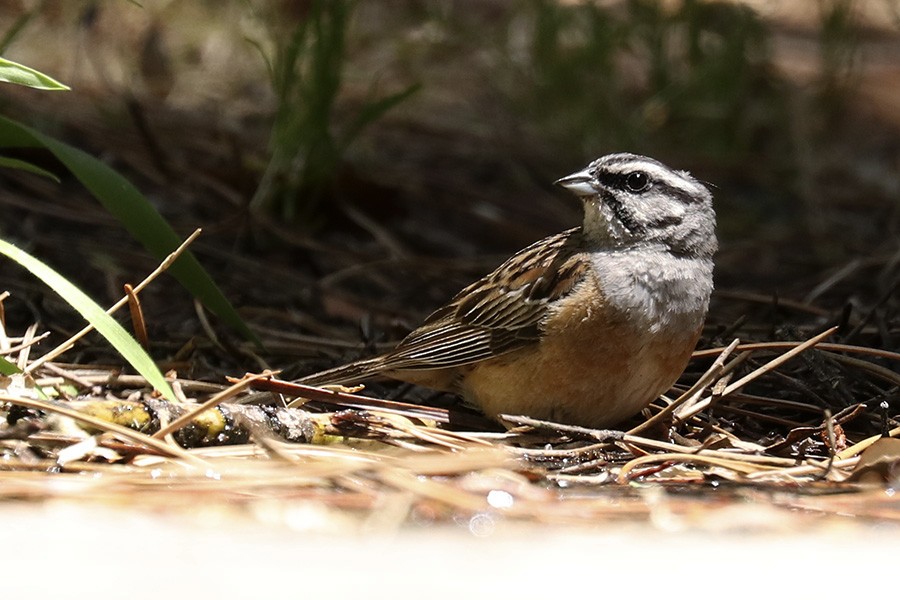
[{"x1": 0, "y1": 240, "x2": 178, "y2": 402}]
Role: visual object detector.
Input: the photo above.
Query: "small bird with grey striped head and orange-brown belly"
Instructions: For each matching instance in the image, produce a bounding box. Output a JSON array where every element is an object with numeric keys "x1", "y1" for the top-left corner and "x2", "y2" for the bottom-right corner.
[{"x1": 298, "y1": 153, "x2": 718, "y2": 428}]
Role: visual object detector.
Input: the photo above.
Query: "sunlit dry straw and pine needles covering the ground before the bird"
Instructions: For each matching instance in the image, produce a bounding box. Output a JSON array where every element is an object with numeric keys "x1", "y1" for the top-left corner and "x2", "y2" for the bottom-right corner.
[{"x1": 0, "y1": 264, "x2": 900, "y2": 525}]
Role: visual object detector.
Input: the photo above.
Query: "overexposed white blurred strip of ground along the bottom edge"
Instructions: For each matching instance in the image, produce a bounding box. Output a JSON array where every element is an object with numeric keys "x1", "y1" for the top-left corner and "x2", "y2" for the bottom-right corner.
[{"x1": 0, "y1": 494, "x2": 900, "y2": 599}]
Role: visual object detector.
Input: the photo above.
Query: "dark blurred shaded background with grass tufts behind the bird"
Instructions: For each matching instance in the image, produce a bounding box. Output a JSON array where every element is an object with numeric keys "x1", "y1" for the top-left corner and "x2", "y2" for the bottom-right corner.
[{"x1": 0, "y1": 0, "x2": 900, "y2": 375}]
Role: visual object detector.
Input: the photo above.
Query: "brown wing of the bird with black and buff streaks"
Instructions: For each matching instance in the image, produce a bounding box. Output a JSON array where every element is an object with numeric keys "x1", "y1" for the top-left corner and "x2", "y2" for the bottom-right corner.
[{"x1": 380, "y1": 228, "x2": 587, "y2": 371}]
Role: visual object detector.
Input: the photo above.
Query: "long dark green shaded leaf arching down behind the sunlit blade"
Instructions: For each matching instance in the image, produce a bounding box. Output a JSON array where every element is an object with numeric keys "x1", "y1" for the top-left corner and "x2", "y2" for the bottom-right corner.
[{"x1": 0, "y1": 116, "x2": 262, "y2": 346}]
